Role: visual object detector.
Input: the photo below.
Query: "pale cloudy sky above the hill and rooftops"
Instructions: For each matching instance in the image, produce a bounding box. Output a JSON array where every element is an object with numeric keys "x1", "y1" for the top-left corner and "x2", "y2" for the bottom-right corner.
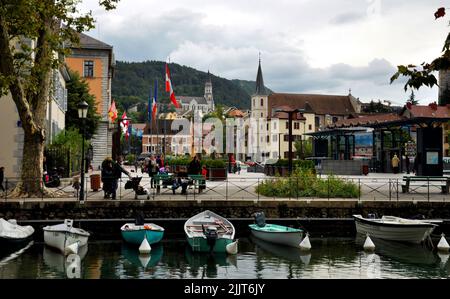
[{"x1": 81, "y1": 0, "x2": 450, "y2": 104}]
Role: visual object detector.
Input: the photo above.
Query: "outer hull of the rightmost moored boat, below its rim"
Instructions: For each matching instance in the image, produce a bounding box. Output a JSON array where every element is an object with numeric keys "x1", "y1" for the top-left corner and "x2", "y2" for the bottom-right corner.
[{"x1": 354, "y1": 217, "x2": 436, "y2": 244}]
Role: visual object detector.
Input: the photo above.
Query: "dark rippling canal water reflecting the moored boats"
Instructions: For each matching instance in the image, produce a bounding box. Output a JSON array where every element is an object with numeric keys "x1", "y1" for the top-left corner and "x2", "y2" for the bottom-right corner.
[{"x1": 0, "y1": 238, "x2": 450, "y2": 279}]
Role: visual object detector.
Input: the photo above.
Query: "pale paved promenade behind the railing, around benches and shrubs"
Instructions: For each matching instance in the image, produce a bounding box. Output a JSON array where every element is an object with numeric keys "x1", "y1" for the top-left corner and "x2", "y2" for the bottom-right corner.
[{"x1": 0, "y1": 167, "x2": 450, "y2": 202}]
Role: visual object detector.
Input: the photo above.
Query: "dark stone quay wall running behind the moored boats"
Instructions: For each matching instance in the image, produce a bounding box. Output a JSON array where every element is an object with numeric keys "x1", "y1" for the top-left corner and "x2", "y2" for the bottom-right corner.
[{"x1": 0, "y1": 200, "x2": 450, "y2": 239}]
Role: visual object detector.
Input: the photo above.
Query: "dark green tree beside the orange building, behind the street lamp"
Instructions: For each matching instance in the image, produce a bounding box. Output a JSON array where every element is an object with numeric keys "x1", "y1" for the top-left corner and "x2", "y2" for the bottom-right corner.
[{"x1": 66, "y1": 71, "x2": 100, "y2": 139}]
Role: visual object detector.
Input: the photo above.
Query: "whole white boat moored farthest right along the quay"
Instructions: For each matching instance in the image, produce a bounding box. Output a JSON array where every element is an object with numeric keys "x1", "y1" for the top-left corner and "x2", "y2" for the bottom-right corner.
[{"x1": 353, "y1": 215, "x2": 437, "y2": 244}]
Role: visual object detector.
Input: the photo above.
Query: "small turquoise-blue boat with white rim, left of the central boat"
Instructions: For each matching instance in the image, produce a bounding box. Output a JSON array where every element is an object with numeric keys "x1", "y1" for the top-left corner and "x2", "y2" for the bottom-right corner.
[{"x1": 120, "y1": 223, "x2": 164, "y2": 245}]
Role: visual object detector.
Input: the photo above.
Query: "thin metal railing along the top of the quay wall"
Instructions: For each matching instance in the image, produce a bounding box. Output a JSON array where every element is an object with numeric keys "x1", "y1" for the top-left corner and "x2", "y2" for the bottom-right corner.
[{"x1": 0, "y1": 174, "x2": 450, "y2": 202}]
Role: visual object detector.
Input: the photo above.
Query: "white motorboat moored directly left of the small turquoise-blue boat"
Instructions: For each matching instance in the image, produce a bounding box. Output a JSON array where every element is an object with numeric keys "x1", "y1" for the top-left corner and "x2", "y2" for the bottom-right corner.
[{"x1": 43, "y1": 219, "x2": 90, "y2": 254}]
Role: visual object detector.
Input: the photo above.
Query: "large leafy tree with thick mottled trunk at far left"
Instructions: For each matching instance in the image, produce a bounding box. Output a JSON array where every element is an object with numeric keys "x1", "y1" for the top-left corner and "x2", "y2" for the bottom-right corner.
[{"x1": 0, "y1": 0, "x2": 119, "y2": 196}]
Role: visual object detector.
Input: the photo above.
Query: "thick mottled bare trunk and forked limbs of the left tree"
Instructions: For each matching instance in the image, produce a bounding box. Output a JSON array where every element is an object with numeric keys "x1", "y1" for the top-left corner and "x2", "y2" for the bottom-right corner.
[{"x1": 0, "y1": 12, "x2": 56, "y2": 197}]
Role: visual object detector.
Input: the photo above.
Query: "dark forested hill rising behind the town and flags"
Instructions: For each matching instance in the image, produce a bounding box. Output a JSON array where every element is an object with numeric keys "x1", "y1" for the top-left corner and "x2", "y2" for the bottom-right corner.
[{"x1": 112, "y1": 61, "x2": 272, "y2": 109}]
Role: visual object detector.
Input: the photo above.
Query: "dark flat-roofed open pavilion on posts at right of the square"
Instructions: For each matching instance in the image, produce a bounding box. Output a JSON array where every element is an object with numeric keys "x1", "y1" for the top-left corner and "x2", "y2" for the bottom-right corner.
[{"x1": 320, "y1": 103, "x2": 450, "y2": 176}]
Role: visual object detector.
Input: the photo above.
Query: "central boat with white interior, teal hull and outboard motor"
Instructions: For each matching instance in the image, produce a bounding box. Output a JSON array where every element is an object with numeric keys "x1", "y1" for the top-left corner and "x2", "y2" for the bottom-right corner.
[{"x1": 184, "y1": 210, "x2": 237, "y2": 254}]
